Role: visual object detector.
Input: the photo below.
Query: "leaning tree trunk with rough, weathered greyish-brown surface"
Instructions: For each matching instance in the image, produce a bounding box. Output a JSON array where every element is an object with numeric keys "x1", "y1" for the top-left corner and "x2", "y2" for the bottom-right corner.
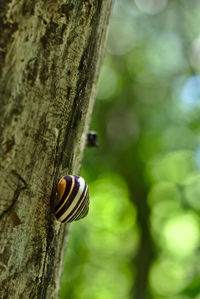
[{"x1": 0, "y1": 0, "x2": 112, "y2": 299}]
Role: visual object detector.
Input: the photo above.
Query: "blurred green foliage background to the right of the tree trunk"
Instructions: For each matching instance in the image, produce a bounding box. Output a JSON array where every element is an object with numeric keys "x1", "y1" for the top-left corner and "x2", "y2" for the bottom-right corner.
[{"x1": 60, "y1": 0, "x2": 200, "y2": 299}]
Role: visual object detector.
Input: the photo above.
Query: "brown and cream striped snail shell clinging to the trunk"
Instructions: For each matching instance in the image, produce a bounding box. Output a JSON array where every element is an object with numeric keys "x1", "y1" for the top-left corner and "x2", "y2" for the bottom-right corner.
[{"x1": 55, "y1": 175, "x2": 89, "y2": 222}]
